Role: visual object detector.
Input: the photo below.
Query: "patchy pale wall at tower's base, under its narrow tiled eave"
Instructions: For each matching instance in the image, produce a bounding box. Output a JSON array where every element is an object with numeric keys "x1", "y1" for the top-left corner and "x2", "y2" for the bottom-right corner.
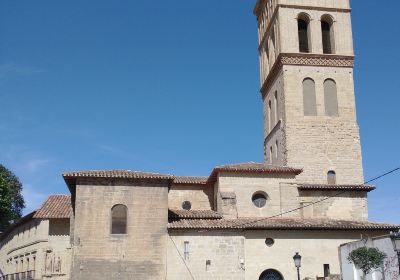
[{"x1": 300, "y1": 190, "x2": 368, "y2": 221}]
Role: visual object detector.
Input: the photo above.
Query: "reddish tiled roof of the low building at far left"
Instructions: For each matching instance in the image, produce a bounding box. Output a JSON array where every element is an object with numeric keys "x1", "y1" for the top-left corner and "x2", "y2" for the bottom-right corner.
[{"x1": 33, "y1": 195, "x2": 72, "y2": 219}]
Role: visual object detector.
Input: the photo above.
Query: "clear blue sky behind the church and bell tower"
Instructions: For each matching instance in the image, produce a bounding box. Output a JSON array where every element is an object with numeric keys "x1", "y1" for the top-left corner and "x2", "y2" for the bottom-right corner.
[{"x1": 0, "y1": 0, "x2": 400, "y2": 223}]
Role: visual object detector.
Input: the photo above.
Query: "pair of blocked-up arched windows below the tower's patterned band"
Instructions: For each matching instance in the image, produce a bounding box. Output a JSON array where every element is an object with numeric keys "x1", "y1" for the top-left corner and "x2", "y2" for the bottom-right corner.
[{"x1": 303, "y1": 78, "x2": 339, "y2": 117}]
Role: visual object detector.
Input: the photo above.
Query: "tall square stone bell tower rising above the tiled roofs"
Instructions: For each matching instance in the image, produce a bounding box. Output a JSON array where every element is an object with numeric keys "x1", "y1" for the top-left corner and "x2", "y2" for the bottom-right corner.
[{"x1": 254, "y1": 0, "x2": 363, "y2": 184}]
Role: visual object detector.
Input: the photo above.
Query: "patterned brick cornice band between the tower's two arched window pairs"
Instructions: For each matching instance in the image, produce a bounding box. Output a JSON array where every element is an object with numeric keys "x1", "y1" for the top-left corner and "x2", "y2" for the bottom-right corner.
[{"x1": 260, "y1": 53, "x2": 354, "y2": 98}]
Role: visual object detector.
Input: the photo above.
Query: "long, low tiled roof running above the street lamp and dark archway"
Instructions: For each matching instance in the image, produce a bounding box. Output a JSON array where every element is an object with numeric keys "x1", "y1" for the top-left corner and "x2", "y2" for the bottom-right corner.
[{"x1": 168, "y1": 218, "x2": 400, "y2": 230}]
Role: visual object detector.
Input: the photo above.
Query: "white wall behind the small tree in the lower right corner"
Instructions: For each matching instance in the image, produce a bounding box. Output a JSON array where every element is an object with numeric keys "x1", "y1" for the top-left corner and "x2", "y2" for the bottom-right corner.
[{"x1": 340, "y1": 236, "x2": 399, "y2": 280}]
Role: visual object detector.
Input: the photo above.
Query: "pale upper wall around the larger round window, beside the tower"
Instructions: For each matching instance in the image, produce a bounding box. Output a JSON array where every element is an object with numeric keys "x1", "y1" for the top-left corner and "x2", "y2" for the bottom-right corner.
[{"x1": 218, "y1": 172, "x2": 299, "y2": 218}]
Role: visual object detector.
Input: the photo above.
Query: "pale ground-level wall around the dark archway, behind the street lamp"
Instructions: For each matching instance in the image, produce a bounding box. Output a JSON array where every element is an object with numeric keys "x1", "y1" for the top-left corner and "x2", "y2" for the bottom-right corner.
[{"x1": 245, "y1": 230, "x2": 383, "y2": 280}]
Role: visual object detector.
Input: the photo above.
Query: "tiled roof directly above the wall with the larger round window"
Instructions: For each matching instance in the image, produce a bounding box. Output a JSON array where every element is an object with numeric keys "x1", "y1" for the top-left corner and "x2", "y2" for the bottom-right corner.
[{"x1": 207, "y1": 162, "x2": 303, "y2": 184}]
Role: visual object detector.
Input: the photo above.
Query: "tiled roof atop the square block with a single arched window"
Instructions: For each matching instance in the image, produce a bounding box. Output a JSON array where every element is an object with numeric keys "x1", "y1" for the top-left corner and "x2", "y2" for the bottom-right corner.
[{"x1": 63, "y1": 170, "x2": 174, "y2": 179}]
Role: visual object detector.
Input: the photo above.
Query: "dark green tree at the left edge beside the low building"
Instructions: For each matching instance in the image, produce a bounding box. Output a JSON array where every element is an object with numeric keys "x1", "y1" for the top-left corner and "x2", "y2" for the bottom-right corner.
[{"x1": 0, "y1": 164, "x2": 25, "y2": 232}]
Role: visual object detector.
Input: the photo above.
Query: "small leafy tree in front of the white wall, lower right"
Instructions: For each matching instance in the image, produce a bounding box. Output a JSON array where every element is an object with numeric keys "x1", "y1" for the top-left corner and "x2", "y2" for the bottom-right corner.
[{"x1": 347, "y1": 247, "x2": 386, "y2": 279}]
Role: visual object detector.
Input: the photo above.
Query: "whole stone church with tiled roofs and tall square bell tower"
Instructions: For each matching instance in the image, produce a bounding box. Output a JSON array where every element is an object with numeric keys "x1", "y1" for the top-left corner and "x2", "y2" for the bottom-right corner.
[{"x1": 0, "y1": 0, "x2": 400, "y2": 280}]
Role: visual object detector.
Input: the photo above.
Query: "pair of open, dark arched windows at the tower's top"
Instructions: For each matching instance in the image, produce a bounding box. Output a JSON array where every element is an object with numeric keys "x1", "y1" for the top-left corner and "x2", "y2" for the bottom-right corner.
[{"x1": 297, "y1": 13, "x2": 334, "y2": 54}]
